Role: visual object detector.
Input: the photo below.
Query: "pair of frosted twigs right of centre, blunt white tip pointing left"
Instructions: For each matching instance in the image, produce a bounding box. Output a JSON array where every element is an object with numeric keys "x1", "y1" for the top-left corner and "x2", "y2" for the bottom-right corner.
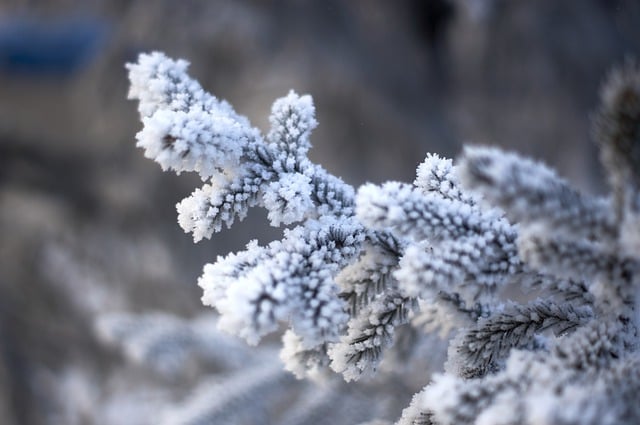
[{"x1": 356, "y1": 182, "x2": 522, "y2": 301}]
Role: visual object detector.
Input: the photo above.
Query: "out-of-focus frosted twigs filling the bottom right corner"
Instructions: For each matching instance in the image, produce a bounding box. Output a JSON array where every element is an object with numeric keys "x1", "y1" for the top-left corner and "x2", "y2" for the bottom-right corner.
[{"x1": 422, "y1": 322, "x2": 640, "y2": 425}]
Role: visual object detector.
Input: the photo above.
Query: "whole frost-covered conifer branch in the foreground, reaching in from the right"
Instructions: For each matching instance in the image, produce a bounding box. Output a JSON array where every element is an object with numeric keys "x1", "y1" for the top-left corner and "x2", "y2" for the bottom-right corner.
[{"x1": 129, "y1": 53, "x2": 640, "y2": 425}]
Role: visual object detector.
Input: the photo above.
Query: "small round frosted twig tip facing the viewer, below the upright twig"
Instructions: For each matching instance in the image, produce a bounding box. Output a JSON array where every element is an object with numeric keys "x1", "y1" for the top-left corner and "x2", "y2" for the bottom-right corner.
[{"x1": 262, "y1": 173, "x2": 314, "y2": 227}]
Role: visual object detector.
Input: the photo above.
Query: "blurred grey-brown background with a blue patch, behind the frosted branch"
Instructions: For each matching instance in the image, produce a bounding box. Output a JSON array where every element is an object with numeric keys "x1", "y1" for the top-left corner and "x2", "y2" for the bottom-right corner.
[{"x1": 0, "y1": 0, "x2": 640, "y2": 425}]
